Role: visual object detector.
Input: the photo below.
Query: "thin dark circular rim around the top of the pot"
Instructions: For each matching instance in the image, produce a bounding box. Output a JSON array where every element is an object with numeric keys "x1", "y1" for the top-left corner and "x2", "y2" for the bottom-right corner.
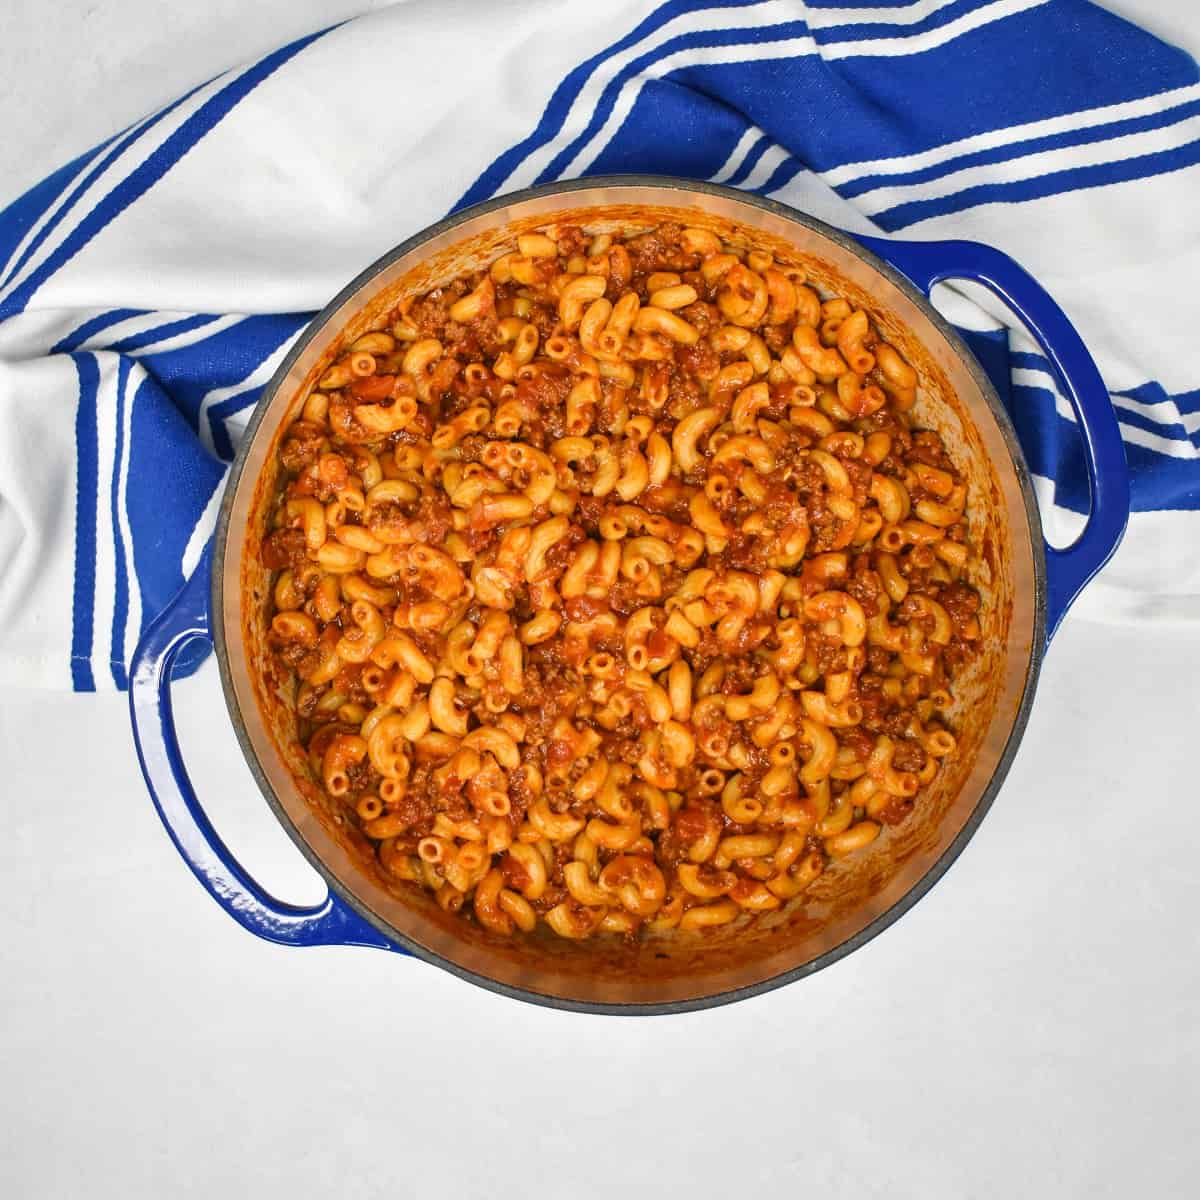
[{"x1": 209, "y1": 174, "x2": 1046, "y2": 1016}]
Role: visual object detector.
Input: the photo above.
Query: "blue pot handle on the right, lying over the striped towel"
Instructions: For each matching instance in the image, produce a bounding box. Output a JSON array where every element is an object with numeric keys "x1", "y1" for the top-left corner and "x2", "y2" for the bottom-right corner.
[{"x1": 858, "y1": 236, "x2": 1129, "y2": 641}]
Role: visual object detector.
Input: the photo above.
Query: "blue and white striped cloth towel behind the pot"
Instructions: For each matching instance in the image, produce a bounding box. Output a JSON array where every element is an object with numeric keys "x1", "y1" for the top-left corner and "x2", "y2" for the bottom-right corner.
[{"x1": 0, "y1": 0, "x2": 1200, "y2": 690}]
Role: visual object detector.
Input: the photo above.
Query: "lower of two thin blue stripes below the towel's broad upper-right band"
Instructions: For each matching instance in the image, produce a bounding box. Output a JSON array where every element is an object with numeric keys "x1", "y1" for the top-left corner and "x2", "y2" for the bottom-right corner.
[{"x1": 871, "y1": 139, "x2": 1200, "y2": 232}]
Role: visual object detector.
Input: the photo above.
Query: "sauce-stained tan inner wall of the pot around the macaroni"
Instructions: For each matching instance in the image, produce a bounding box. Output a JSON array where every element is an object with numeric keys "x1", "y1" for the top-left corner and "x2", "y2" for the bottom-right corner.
[{"x1": 214, "y1": 182, "x2": 1042, "y2": 1010}]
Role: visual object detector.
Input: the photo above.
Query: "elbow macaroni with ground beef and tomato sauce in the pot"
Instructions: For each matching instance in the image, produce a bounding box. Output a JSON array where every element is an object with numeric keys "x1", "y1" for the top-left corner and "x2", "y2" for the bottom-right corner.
[{"x1": 262, "y1": 224, "x2": 980, "y2": 938}]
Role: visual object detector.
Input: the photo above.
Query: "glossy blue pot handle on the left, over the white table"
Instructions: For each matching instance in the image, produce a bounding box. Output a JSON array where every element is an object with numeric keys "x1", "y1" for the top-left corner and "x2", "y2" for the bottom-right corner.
[{"x1": 130, "y1": 542, "x2": 407, "y2": 953}]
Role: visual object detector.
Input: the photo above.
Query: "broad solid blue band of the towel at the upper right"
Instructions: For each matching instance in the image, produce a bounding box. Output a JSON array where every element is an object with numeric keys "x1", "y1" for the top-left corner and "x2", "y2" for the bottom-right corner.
[{"x1": 672, "y1": 0, "x2": 1200, "y2": 172}]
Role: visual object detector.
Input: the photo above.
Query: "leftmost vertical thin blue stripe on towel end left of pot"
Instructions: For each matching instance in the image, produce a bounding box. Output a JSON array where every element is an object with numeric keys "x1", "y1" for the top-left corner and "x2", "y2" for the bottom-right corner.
[{"x1": 71, "y1": 354, "x2": 100, "y2": 691}]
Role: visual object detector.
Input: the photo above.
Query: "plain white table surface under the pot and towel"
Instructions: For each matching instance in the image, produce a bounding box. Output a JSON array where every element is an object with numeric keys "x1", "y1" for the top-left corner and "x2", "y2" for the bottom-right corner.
[{"x1": 0, "y1": 0, "x2": 1200, "y2": 1200}]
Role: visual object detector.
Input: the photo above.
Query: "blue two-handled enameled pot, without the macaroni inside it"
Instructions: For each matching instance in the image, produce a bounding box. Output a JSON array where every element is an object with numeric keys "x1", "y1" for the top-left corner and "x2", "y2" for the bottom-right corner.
[{"x1": 130, "y1": 176, "x2": 1129, "y2": 1014}]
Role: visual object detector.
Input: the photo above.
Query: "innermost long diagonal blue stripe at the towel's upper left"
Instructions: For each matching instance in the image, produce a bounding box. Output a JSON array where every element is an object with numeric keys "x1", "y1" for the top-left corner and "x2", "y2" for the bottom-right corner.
[{"x1": 0, "y1": 30, "x2": 328, "y2": 318}]
